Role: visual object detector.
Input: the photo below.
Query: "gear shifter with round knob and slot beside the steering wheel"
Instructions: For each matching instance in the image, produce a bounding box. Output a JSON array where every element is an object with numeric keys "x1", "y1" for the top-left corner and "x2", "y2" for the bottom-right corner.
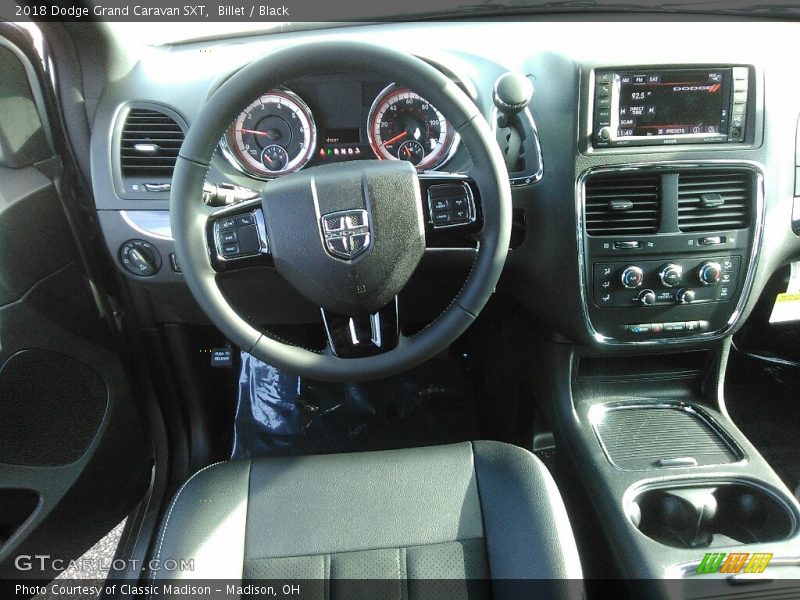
[{"x1": 492, "y1": 71, "x2": 542, "y2": 185}]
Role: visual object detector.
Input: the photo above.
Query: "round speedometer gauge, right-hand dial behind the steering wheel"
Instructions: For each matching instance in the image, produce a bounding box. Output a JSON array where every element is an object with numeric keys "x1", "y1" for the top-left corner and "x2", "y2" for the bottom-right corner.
[{"x1": 367, "y1": 85, "x2": 455, "y2": 171}]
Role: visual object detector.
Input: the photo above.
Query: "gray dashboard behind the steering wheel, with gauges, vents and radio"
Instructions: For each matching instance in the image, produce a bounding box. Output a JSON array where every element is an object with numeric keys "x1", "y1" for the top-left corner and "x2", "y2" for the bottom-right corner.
[{"x1": 91, "y1": 20, "x2": 800, "y2": 351}]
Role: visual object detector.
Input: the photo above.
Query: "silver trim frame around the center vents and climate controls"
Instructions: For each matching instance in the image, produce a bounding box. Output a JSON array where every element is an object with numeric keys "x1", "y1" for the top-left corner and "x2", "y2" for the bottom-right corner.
[{"x1": 575, "y1": 159, "x2": 765, "y2": 346}]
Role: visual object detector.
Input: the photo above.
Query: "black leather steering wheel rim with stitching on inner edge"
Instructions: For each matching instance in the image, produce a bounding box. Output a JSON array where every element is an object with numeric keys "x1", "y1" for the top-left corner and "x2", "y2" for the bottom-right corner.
[{"x1": 170, "y1": 41, "x2": 511, "y2": 381}]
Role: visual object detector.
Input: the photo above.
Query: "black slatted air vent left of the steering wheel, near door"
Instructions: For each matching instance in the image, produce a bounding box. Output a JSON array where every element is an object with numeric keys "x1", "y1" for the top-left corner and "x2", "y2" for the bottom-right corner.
[{"x1": 120, "y1": 108, "x2": 184, "y2": 179}]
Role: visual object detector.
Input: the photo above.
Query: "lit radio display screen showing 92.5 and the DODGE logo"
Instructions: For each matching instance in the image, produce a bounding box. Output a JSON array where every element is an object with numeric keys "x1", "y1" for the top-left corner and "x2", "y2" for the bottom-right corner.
[{"x1": 615, "y1": 69, "x2": 731, "y2": 139}]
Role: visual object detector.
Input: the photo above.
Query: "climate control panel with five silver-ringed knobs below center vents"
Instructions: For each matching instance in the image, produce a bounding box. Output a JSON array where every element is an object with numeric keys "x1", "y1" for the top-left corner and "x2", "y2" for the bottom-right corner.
[{"x1": 592, "y1": 256, "x2": 742, "y2": 308}]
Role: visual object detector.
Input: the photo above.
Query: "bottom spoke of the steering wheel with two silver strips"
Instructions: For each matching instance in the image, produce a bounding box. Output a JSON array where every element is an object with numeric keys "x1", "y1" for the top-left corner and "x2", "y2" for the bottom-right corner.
[{"x1": 320, "y1": 297, "x2": 402, "y2": 358}]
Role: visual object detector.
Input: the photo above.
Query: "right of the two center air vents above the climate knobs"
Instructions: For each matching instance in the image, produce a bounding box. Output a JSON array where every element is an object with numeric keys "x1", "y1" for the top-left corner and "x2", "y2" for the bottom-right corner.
[{"x1": 678, "y1": 169, "x2": 754, "y2": 232}]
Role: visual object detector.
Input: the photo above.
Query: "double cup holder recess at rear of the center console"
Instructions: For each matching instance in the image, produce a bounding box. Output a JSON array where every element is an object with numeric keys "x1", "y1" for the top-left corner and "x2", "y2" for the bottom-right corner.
[{"x1": 626, "y1": 481, "x2": 796, "y2": 548}]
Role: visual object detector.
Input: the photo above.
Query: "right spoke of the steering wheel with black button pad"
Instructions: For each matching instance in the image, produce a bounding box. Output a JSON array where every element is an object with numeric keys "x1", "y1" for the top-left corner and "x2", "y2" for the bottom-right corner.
[{"x1": 419, "y1": 171, "x2": 483, "y2": 248}]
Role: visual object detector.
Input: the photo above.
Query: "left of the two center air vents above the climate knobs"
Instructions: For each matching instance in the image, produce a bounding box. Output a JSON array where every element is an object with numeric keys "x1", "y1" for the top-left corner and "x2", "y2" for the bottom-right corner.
[{"x1": 586, "y1": 173, "x2": 660, "y2": 235}]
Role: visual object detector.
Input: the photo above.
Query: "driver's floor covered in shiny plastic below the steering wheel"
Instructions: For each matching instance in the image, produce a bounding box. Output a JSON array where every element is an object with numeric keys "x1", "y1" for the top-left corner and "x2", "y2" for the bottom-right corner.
[{"x1": 231, "y1": 352, "x2": 479, "y2": 459}]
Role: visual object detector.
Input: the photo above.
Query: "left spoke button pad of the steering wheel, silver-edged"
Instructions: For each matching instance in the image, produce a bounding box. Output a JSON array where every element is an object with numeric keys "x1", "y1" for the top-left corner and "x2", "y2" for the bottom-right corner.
[{"x1": 206, "y1": 197, "x2": 272, "y2": 271}]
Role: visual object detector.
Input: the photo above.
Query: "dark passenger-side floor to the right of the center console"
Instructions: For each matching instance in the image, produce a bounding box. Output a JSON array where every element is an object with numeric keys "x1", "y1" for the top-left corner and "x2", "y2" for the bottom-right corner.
[{"x1": 725, "y1": 352, "x2": 800, "y2": 491}]
